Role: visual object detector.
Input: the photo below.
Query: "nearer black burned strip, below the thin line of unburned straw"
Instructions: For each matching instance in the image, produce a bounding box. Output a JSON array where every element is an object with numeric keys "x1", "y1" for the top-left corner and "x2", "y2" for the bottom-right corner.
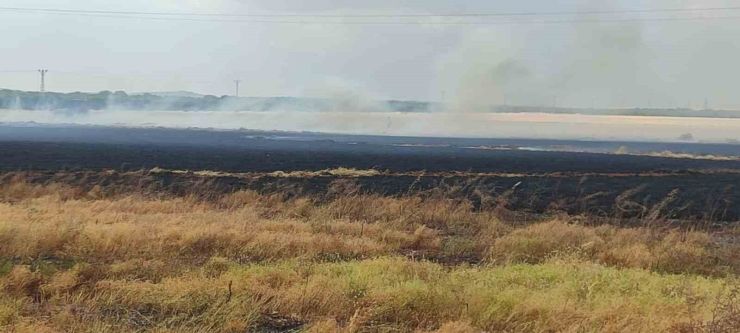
[{"x1": 5, "y1": 169, "x2": 740, "y2": 222}]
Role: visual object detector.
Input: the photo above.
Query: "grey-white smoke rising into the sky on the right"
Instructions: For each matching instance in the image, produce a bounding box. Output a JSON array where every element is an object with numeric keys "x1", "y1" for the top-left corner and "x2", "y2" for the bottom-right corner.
[{"x1": 436, "y1": 1, "x2": 740, "y2": 110}]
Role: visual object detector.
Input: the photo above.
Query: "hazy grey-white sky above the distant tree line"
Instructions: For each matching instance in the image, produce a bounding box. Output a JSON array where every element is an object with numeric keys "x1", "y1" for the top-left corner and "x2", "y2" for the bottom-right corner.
[{"x1": 0, "y1": 0, "x2": 740, "y2": 109}]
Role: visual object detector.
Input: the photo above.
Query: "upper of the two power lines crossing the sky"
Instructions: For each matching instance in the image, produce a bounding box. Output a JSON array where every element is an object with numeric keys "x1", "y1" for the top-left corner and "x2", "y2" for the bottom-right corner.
[{"x1": 0, "y1": 6, "x2": 740, "y2": 18}]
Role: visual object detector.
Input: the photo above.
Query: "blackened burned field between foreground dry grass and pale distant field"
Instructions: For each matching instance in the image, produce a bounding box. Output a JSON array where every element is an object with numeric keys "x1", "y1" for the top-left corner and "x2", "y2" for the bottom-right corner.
[{"x1": 0, "y1": 123, "x2": 740, "y2": 221}]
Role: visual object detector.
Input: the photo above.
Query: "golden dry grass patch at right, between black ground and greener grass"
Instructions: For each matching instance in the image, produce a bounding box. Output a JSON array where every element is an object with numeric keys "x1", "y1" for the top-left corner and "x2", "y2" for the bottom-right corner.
[{"x1": 488, "y1": 221, "x2": 740, "y2": 276}]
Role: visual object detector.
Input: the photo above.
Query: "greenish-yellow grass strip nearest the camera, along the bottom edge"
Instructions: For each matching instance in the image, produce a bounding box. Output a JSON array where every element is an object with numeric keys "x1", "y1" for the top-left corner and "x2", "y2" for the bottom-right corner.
[{"x1": 0, "y1": 258, "x2": 724, "y2": 332}]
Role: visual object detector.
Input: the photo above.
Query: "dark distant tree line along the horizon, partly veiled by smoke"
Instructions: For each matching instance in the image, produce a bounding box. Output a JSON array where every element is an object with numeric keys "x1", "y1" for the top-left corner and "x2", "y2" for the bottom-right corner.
[{"x1": 0, "y1": 90, "x2": 740, "y2": 118}]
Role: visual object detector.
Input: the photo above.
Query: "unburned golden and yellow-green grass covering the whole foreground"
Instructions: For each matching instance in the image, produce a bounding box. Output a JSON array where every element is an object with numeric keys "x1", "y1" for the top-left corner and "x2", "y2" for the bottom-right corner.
[{"x1": 0, "y1": 169, "x2": 740, "y2": 332}]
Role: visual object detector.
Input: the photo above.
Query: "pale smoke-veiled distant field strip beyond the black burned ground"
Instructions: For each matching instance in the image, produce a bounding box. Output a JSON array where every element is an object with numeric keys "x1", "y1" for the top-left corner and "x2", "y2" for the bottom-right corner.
[{"x1": 0, "y1": 110, "x2": 740, "y2": 142}]
